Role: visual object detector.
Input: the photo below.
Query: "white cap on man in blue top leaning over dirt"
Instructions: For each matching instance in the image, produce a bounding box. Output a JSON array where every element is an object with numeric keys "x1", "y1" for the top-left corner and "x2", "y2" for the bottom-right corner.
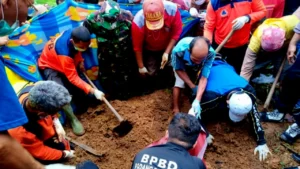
[{"x1": 228, "y1": 92, "x2": 252, "y2": 122}]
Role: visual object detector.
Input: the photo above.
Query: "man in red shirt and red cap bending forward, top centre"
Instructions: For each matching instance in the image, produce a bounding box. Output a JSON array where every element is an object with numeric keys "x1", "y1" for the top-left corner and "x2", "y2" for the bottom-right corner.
[{"x1": 131, "y1": 0, "x2": 182, "y2": 87}]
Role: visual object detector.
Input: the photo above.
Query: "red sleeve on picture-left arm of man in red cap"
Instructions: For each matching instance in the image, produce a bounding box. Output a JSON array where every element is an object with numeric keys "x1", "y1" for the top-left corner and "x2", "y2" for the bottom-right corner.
[{"x1": 131, "y1": 22, "x2": 144, "y2": 52}]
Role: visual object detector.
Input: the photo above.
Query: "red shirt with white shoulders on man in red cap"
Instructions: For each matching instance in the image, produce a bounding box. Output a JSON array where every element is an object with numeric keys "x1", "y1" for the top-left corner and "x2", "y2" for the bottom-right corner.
[{"x1": 131, "y1": 1, "x2": 182, "y2": 52}]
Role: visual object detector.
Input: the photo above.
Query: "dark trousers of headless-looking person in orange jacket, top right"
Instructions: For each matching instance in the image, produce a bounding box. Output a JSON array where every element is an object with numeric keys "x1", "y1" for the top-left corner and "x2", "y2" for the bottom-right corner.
[{"x1": 212, "y1": 42, "x2": 248, "y2": 74}]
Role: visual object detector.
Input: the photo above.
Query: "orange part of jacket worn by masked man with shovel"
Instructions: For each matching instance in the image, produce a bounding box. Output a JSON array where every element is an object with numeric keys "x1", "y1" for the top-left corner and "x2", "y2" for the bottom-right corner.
[{"x1": 38, "y1": 37, "x2": 91, "y2": 94}]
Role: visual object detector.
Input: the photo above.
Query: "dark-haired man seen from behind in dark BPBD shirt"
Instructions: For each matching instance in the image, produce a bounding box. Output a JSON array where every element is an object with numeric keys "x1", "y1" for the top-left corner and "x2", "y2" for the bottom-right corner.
[{"x1": 131, "y1": 113, "x2": 206, "y2": 169}]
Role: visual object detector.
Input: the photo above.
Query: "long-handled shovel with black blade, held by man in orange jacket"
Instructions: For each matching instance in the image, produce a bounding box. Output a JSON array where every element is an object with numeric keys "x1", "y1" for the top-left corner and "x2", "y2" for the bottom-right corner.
[{"x1": 83, "y1": 73, "x2": 132, "y2": 136}]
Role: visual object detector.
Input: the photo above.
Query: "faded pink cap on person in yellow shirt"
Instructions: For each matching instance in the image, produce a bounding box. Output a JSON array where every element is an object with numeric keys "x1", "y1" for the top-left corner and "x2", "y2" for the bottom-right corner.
[{"x1": 261, "y1": 27, "x2": 285, "y2": 52}]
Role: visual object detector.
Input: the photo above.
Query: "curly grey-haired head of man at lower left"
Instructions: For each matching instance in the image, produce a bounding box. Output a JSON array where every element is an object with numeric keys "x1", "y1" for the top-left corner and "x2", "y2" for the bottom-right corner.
[{"x1": 28, "y1": 81, "x2": 71, "y2": 114}]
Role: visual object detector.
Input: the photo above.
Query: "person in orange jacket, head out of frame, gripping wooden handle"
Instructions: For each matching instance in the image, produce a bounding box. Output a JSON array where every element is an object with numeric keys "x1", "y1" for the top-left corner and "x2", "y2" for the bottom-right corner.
[{"x1": 204, "y1": 0, "x2": 266, "y2": 73}]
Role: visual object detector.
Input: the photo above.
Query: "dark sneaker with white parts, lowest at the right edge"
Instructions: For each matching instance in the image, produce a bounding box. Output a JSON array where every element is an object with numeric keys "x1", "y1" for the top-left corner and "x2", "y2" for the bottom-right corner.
[{"x1": 280, "y1": 123, "x2": 300, "y2": 144}]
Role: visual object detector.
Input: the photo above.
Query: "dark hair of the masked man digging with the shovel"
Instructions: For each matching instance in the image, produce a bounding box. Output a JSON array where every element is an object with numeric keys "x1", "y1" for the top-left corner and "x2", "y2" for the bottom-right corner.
[{"x1": 71, "y1": 26, "x2": 91, "y2": 43}]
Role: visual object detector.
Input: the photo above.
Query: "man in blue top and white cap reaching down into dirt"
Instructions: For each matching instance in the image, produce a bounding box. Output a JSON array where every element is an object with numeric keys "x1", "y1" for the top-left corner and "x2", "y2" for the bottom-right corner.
[{"x1": 189, "y1": 57, "x2": 270, "y2": 161}]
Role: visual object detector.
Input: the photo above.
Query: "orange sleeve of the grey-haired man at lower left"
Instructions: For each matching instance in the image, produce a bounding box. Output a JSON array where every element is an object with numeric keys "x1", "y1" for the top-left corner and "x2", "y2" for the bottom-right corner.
[{"x1": 9, "y1": 126, "x2": 63, "y2": 160}]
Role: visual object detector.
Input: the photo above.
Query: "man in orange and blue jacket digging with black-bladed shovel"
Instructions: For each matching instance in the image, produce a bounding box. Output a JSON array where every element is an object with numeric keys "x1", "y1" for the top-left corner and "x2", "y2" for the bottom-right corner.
[{"x1": 38, "y1": 26, "x2": 104, "y2": 135}]
